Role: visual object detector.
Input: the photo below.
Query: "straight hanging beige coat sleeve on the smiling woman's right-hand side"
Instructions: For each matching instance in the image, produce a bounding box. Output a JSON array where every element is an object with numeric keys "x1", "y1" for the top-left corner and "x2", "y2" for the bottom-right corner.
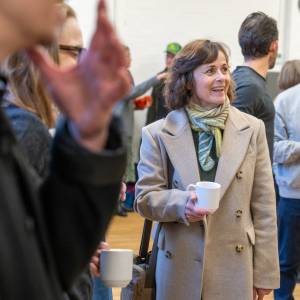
[{"x1": 251, "y1": 121, "x2": 279, "y2": 289}]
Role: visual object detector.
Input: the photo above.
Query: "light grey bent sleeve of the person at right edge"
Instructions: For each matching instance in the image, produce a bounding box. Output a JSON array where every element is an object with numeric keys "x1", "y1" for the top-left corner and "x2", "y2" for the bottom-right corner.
[{"x1": 273, "y1": 101, "x2": 300, "y2": 164}]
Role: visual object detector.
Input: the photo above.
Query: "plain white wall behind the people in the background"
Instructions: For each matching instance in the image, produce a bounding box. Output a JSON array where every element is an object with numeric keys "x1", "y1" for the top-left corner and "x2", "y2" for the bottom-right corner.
[{"x1": 69, "y1": 0, "x2": 300, "y2": 162}]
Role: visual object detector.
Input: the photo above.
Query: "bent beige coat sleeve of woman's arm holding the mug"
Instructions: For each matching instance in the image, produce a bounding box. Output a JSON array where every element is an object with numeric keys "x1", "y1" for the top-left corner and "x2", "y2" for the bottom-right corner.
[{"x1": 135, "y1": 127, "x2": 189, "y2": 225}]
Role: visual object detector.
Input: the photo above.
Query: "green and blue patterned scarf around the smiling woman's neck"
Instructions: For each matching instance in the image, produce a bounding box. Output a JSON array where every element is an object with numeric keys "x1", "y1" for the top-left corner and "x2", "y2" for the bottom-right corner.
[{"x1": 185, "y1": 98, "x2": 230, "y2": 172}]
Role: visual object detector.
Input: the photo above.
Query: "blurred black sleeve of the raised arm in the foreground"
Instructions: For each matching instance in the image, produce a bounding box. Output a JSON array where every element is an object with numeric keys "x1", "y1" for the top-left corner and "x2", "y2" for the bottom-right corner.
[{"x1": 40, "y1": 118, "x2": 126, "y2": 290}]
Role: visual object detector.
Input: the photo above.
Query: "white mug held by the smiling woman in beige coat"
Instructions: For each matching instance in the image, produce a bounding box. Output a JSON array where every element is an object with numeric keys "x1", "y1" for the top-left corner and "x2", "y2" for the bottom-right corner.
[{"x1": 187, "y1": 181, "x2": 221, "y2": 213}]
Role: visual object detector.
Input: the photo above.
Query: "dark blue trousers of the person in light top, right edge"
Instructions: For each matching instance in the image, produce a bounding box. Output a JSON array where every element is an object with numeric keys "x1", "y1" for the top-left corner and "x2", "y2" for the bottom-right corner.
[{"x1": 274, "y1": 197, "x2": 300, "y2": 300}]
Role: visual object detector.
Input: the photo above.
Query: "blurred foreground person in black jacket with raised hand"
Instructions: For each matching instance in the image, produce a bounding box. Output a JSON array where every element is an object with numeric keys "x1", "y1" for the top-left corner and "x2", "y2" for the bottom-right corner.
[{"x1": 0, "y1": 0, "x2": 129, "y2": 300}]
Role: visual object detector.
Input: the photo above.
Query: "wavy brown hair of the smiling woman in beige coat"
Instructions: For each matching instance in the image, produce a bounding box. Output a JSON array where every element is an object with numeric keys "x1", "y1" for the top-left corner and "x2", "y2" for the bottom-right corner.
[{"x1": 164, "y1": 40, "x2": 234, "y2": 110}]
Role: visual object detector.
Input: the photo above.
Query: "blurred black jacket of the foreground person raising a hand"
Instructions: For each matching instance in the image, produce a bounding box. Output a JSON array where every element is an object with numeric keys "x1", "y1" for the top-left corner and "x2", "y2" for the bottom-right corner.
[{"x1": 0, "y1": 76, "x2": 126, "y2": 300}]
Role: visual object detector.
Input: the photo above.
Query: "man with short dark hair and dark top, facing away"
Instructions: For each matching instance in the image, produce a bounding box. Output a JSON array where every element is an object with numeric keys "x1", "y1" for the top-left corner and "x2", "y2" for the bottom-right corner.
[{"x1": 233, "y1": 12, "x2": 278, "y2": 161}]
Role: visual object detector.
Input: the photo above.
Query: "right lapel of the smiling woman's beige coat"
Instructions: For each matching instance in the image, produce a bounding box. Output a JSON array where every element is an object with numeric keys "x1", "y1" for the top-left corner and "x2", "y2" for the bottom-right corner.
[{"x1": 215, "y1": 107, "x2": 253, "y2": 199}]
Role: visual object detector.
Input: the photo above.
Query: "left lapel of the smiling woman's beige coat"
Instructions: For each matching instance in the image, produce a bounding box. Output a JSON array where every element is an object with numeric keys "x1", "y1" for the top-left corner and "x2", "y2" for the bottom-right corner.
[{"x1": 160, "y1": 109, "x2": 200, "y2": 188}]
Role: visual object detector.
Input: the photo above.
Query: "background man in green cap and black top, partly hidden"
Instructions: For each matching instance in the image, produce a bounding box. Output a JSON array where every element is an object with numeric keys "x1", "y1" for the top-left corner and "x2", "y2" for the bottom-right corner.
[{"x1": 146, "y1": 43, "x2": 182, "y2": 124}]
